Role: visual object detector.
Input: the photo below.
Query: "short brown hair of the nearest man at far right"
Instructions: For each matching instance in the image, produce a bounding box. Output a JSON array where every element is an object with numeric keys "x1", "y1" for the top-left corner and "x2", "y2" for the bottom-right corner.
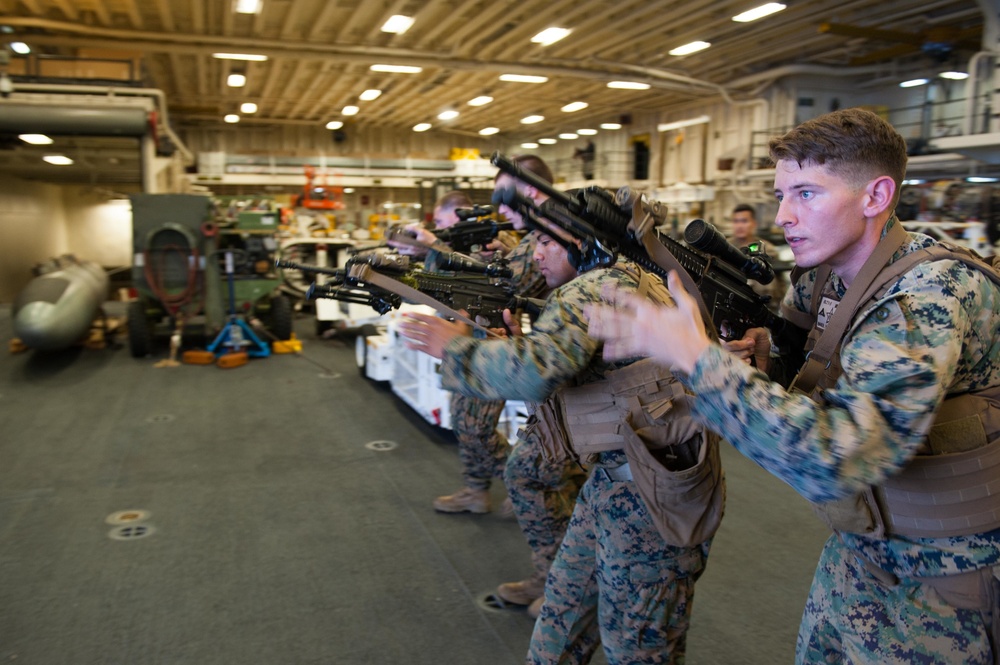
[{"x1": 768, "y1": 108, "x2": 906, "y2": 206}]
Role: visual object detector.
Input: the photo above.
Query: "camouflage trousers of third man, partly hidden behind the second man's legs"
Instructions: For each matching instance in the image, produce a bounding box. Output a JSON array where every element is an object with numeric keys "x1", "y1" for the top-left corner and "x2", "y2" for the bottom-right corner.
[{"x1": 503, "y1": 432, "x2": 587, "y2": 575}]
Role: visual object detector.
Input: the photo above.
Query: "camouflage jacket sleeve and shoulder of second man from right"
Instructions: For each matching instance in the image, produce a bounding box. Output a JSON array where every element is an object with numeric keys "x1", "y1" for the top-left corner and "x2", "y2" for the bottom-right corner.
[{"x1": 441, "y1": 268, "x2": 638, "y2": 402}]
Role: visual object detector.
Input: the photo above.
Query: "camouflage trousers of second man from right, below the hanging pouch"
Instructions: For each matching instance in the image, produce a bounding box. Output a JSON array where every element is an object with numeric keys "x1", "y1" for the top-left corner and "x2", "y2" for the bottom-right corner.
[{"x1": 526, "y1": 469, "x2": 710, "y2": 665}]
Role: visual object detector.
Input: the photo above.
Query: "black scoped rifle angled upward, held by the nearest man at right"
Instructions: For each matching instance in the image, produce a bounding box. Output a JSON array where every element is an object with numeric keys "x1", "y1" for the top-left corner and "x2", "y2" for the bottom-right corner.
[{"x1": 490, "y1": 153, "x2": 787, "y2": 339}]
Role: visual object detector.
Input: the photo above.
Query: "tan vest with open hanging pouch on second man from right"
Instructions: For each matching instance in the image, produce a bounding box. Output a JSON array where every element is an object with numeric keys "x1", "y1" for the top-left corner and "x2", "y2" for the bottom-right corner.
[{"x1": 526, "y1": 267, "x2": 726, "y2": 547}]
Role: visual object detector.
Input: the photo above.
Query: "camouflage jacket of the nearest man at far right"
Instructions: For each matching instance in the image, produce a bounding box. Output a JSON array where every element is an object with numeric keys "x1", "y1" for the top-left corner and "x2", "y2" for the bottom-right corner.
[{"x1": 682, "y1": 221, "x2": 1000, "y2": 577}]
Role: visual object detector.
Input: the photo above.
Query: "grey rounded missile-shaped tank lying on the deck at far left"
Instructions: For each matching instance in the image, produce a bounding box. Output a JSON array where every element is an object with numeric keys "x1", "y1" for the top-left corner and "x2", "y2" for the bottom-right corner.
[{"x1": 11, "y1": 256, "x2": 108, "y2": 351}]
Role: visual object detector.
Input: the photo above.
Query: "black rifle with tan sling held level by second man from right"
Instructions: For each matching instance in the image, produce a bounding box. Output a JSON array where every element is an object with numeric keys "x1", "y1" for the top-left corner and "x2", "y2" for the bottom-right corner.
[{"x1": 276, "y1": 253, "x2": 544, "y2": 328}]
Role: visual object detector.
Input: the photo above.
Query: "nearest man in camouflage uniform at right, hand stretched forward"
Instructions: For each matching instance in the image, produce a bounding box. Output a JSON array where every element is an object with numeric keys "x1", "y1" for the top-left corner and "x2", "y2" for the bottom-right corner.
[{"x1": 590, "y1": 109, "x2": 1000, "y2": 665}]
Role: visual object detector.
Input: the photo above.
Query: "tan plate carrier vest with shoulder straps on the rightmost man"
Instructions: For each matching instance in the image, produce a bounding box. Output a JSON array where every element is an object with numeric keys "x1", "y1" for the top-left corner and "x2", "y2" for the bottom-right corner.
[{"x1": 782, "y1": 222, "x2": 1000, "y2": 538}]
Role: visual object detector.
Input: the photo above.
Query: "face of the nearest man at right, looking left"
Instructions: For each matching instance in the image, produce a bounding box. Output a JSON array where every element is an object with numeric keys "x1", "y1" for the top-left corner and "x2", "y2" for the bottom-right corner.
[{"x1": 774, "y1": 159, "x2": 881, "y2": 281}]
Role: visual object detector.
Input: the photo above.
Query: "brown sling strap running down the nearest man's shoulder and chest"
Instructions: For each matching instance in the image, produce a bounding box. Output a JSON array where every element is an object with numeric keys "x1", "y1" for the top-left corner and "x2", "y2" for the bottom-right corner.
[{"x1": 792, "y1": 222, "x2": 910, "y2": 395}]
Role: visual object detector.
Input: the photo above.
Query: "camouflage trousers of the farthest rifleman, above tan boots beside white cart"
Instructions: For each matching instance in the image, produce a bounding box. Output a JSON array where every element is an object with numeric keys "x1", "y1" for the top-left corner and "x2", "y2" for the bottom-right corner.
[{"x1": 450, "y1": 393, "x2": 510, "y2": 490}]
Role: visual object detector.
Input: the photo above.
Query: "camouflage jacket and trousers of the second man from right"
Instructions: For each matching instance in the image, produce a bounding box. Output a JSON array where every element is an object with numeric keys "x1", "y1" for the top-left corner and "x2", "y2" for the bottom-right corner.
[{"x1": 441, "y1": 269, "x2": 708, "y2": 665}]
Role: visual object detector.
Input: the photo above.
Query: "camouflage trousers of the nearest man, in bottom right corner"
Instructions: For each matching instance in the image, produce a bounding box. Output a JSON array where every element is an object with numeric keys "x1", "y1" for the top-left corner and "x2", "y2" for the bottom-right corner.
[{"x1": 795, "y1": 535, "x2": 1000, "y2": 665}]
